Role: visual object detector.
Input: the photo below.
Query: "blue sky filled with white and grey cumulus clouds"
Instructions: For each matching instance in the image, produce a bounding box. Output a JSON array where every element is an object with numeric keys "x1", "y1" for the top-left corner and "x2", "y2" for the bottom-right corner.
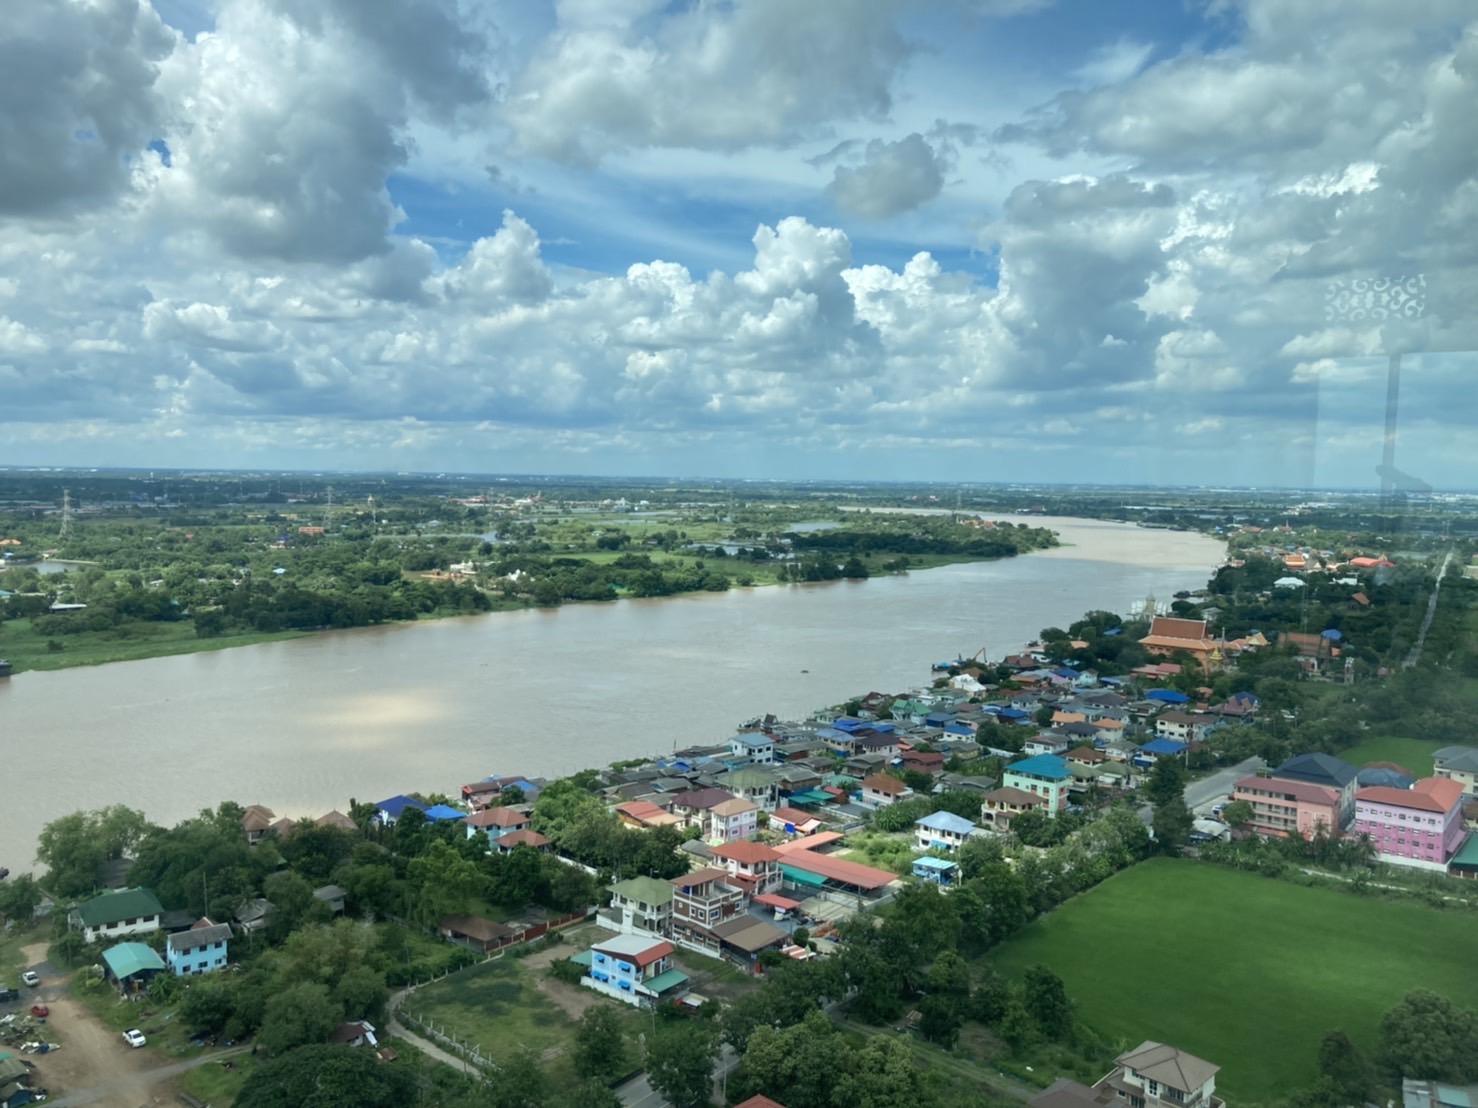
[{"x1": 0, "y1": 0, "x2": 1478, "y2": 489}]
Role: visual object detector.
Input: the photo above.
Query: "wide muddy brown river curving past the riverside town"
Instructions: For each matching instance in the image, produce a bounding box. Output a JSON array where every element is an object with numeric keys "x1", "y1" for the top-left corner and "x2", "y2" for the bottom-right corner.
[{"x1": 0, "y1": 517, "x2": 1225, "y2": 872}]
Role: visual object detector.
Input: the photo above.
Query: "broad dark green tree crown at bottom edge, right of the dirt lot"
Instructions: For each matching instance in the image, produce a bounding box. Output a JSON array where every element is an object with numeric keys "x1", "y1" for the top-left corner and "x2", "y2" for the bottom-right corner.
[{"x1": 235, "y1": 1044, "x2": 415, "y2": 1108}]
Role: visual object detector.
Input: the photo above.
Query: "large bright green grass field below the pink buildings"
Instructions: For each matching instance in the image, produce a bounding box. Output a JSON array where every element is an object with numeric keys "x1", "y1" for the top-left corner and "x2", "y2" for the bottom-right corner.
[{"x1": 993, "y1": 858, "x2": 1478, "y2": 1105}]
